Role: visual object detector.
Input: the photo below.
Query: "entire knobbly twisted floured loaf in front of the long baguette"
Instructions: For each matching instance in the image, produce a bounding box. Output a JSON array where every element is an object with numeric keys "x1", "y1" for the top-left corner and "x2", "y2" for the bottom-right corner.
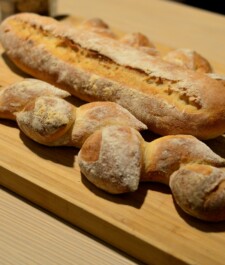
[{"x1": 0, "y1": 79, "x2": 225, "y2": 221}]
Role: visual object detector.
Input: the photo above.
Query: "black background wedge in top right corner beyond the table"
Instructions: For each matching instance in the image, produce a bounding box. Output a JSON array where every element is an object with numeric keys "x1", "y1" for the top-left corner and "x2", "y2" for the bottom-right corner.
[{"x1": 172, "y1": 0, "x2": 225, "y2": 15}]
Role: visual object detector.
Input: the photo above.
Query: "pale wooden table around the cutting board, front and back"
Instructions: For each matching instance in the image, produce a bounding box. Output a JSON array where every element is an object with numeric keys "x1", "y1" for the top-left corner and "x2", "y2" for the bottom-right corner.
[{"x1": 0, "y1": 0, "x2": 225, "y2": 265}]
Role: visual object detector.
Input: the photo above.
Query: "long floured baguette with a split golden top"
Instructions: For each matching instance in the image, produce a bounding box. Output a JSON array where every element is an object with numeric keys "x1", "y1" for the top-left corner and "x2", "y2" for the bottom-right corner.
[{"x1": 0, "y1": 13, "x2": 225, "y2": 139}]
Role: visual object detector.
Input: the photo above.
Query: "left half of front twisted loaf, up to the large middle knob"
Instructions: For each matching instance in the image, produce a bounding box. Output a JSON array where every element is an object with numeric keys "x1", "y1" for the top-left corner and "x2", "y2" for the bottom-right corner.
[{"x1": 0, "y1": 79, "x2": 147, "y2": 147}]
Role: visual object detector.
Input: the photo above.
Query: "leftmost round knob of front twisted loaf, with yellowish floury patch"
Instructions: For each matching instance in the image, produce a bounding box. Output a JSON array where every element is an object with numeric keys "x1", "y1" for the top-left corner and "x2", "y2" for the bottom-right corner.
[{"x1": 16, "y1": 96, "x2": 76, "y2": 146}]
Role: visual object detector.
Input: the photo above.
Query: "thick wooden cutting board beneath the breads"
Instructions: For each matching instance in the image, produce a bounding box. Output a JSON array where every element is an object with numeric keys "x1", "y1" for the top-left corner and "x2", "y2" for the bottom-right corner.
[{"x1": 0, "y1": 18, "x2": 225, "y2": 265}]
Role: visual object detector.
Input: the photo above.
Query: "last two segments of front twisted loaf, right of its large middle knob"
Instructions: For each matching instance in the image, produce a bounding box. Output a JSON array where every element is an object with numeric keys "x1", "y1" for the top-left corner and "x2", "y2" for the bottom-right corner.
[{"x1": 141, "y1": 135, "x2": 225, "y2": 221}]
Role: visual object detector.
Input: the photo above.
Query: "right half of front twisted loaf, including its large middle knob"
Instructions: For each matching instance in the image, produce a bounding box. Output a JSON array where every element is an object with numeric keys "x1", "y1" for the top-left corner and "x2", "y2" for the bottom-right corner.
[{"x1": 78, "y1": 126, "x2": 225, "y2": 221}]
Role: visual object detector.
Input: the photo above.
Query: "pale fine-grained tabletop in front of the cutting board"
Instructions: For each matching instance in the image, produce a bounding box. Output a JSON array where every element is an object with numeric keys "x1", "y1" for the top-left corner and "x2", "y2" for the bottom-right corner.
[{"x1": 0, "y1": 189, "x2": 140, "y2": 265}]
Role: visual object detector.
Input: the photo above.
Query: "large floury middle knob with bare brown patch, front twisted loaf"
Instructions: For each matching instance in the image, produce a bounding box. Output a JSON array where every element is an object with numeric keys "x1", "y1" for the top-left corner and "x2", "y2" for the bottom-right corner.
[{"x1": 78, "y1": 126, "x2": 142, "y2": 194}]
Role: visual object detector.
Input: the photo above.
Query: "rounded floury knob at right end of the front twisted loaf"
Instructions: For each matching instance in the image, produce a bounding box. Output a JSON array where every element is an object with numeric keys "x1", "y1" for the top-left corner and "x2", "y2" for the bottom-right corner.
[{"x1": 170, "y1": 164, "x2": 225, "y2": 222}]
